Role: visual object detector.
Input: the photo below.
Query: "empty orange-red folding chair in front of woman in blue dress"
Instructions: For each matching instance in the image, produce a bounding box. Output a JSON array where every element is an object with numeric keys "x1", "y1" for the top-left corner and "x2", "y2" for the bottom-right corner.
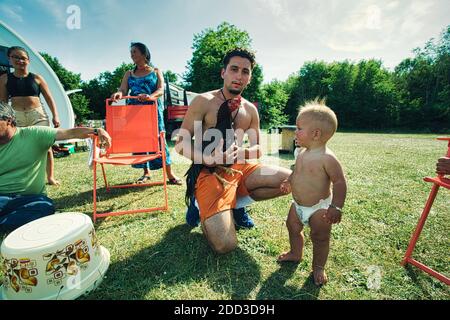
[{"x1": 93, "y1": 96, "x2": 168, "y2": 222}]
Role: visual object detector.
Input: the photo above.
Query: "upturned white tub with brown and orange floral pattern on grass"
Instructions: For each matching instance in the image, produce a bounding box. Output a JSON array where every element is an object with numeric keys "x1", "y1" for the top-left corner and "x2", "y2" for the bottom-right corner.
[{"x1": 1, "y1": 212, "x2": 110, "y2": 300}]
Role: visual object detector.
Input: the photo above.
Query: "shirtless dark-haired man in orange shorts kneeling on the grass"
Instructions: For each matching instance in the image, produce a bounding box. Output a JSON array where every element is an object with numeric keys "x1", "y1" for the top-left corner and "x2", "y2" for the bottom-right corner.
[{"x1": 175, "y1": 48, "x2": 291, "y2": 253}]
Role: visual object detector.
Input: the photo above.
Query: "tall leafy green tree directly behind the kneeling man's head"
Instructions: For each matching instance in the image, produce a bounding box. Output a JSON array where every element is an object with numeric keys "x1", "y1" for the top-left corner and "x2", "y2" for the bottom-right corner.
[{"x1": 184, "y1": 22, "x2": 263, "y2": 101}]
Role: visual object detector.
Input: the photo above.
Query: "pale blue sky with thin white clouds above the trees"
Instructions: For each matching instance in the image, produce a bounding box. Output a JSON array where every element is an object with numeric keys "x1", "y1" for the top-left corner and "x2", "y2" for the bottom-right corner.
[{"x1": 0, "y1": 0, "x2": 450, "y2": 82}]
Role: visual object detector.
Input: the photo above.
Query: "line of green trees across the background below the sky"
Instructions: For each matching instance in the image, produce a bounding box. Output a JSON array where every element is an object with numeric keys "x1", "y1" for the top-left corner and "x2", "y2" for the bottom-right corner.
[{"x1": 42, "y1": 22, "x2": 450, "y2": 132}]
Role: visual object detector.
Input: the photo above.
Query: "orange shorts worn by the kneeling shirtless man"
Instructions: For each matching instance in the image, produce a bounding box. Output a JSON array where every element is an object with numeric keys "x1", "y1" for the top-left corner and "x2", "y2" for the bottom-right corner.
[{"x1": 195, "y1": 163, "x2": 262, "y2": 222}]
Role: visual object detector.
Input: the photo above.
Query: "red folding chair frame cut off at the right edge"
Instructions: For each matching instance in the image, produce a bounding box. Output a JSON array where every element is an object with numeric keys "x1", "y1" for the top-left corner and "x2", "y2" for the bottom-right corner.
[{"x1": 402, "y1": 138, "x2": 450, "y2": 285}]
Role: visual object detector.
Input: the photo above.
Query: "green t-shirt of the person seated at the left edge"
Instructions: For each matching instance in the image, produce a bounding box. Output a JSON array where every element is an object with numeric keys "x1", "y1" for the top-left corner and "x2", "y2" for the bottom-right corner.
[{"x1": 0, "y1": 126, "x2": 57, "y2": 195}]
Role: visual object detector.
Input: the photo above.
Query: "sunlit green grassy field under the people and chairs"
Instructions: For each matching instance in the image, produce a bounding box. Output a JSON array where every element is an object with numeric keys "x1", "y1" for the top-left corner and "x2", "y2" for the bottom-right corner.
[{"x1": 0, "y1": 133, "x2": 450, "y2": 300}]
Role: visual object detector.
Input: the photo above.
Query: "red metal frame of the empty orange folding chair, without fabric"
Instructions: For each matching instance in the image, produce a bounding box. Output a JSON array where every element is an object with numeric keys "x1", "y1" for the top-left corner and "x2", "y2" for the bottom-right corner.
[{"x1": 93, "y1": 96, "x2": 169, "y2": 223}]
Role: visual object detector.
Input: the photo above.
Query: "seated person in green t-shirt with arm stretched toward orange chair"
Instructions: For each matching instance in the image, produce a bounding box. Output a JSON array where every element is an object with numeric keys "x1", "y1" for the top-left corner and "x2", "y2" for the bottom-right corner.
[{"x1": 0, "y1": 102, "x2": 111, "y2": 231}]
